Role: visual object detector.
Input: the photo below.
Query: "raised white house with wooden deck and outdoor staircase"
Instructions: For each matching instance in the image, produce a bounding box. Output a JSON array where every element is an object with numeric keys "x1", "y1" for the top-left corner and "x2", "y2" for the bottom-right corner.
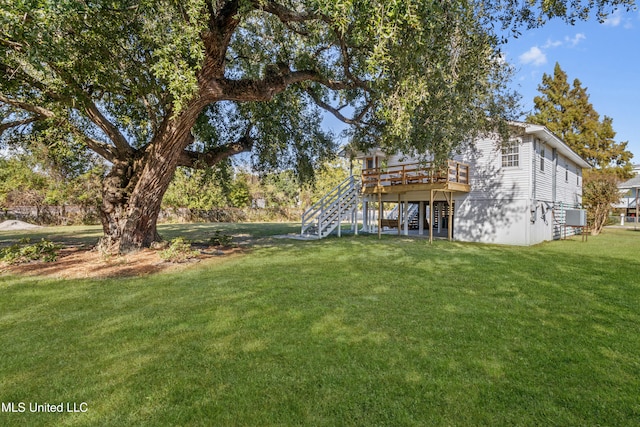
[{"x1": 302, "y1": 123, "x2": 590, "y2": 245}]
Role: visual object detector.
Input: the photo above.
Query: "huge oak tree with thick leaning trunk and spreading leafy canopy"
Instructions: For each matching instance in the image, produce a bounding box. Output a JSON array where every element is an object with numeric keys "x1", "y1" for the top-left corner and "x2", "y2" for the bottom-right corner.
[{"x1": 0, "y1": 0, "x2": 633, "y2": 252}]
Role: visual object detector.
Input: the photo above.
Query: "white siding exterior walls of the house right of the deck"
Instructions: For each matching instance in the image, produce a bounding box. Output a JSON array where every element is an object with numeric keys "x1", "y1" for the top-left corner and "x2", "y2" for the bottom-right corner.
[{"x1": 454, "y1": 135, "x2": 582, "y2": 245}]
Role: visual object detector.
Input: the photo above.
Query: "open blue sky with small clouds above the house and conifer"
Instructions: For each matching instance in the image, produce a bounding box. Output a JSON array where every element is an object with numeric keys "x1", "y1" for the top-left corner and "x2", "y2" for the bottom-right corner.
[{"x1": 502, "y1": 11, "x2": 640, "y2": 164}]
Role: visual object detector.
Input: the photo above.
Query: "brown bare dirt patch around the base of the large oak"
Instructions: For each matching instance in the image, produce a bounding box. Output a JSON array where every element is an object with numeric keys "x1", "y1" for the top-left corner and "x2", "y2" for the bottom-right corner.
[{"x1": 0, "y1": 247, "x2": 246, "y2": 279}]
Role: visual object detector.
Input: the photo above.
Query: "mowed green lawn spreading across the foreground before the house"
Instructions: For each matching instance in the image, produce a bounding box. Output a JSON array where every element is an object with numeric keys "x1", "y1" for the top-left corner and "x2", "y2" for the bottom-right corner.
[{"x1": 0, "y1": 225, "x2": 640, "y2": 426}]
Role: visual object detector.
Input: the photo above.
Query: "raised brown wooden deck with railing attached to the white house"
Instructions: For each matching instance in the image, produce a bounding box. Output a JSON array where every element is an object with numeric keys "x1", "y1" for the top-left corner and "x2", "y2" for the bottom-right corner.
[{"x1": 362, "y1": 160, "x2": 471, "y2": 194}]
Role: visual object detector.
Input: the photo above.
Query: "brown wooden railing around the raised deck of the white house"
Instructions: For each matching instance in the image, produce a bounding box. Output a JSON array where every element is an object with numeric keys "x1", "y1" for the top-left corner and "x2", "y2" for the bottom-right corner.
[{"x1": 362, "y1": 160, "x2": 469, "y2": 188}]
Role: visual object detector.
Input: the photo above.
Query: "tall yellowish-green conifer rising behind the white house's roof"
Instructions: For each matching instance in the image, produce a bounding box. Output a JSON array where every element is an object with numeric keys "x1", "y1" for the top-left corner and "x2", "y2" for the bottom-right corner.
[{"x1": 527, "y1": 63, "x2": 633, "y2": 179}]
